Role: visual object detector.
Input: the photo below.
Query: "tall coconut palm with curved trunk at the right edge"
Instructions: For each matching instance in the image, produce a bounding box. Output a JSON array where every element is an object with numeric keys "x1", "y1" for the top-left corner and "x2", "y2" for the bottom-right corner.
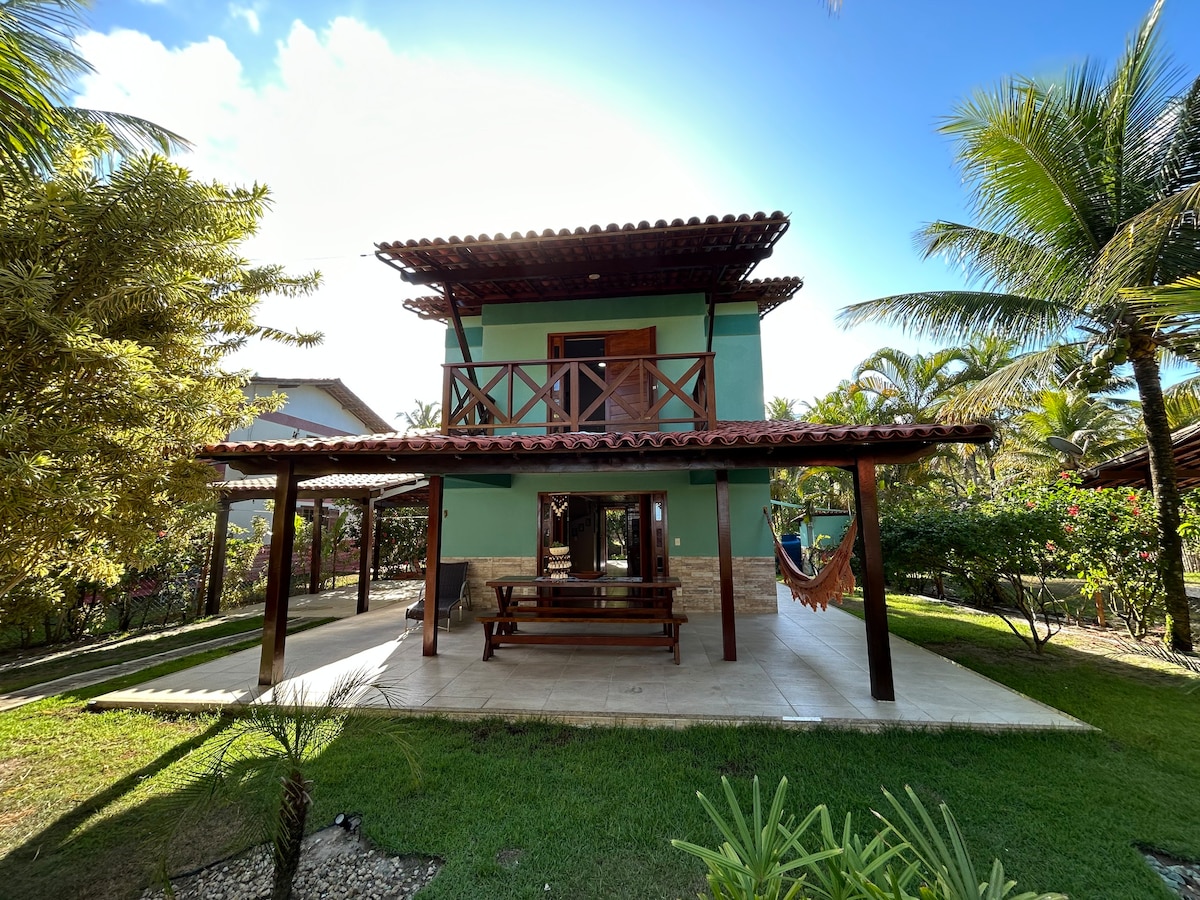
[{"x1": 840, "y1": 0, "x2": 1200, "y2": 649}]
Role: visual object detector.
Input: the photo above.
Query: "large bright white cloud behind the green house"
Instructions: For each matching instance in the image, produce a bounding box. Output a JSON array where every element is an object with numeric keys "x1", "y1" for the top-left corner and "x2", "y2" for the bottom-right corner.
[{"x1": 78, "y1": 13, "x2": 865, "y2": 418}]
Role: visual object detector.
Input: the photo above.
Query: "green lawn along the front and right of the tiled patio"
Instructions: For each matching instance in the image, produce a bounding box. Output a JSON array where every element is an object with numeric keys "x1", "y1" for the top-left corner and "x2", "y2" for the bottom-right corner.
[{"x1": 0, "y1": 598, "x2": 1200, "y2": 900}]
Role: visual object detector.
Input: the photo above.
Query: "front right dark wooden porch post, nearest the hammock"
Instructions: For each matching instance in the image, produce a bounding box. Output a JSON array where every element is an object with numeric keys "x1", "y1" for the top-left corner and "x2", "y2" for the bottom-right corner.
[{"x1": 853, "y1": 456, "x2": 896, "y2": 700}]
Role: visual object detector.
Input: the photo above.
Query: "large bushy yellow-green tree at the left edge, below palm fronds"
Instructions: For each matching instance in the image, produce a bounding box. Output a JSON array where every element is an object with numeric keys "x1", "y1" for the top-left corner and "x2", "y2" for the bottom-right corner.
[{"x1": 0, "y1": 149, "x2": 319, "y2": 607}]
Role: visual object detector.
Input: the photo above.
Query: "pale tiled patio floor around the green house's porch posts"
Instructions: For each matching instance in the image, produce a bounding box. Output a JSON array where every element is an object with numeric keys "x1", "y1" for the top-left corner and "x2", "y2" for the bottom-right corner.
[{"x1": 94, "y1": 588, "x2": 1088, "y2": 728}]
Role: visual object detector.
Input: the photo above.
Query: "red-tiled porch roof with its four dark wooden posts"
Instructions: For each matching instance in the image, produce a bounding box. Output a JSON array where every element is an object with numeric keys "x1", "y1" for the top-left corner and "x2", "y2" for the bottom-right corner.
[{"x1": 202, "y1": 421, "x2": 992, "y2": 700}]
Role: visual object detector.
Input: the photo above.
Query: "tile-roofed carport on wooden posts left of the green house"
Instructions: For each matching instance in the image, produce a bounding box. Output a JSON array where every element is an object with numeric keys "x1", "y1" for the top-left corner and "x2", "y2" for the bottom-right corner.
[{"x1": 204, "y1": 472, "x2": 430, "y2": 616}]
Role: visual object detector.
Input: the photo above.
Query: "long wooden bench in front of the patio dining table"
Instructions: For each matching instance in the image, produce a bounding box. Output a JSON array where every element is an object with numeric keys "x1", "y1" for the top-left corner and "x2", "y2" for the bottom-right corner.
[{"x1": 475, "y1": 606, "x2": 688, "y2": 666}]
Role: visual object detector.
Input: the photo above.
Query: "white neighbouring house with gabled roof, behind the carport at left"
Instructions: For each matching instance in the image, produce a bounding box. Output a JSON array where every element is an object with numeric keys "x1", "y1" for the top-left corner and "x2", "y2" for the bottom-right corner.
[{"x1": 221, "y1": 376, "x2": 396, "y2": 529}]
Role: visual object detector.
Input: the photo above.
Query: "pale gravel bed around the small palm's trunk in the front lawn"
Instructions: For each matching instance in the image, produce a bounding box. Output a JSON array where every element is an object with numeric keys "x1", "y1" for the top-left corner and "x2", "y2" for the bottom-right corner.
[{"x1": 142, "y1": 826, "x2": 442, "y2": 900}]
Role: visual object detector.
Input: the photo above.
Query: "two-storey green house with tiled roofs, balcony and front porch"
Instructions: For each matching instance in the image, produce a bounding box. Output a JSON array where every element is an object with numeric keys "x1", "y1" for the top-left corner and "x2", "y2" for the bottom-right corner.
[{"x1": 202, "y1": 212, "x2": 991, "y2": 700}]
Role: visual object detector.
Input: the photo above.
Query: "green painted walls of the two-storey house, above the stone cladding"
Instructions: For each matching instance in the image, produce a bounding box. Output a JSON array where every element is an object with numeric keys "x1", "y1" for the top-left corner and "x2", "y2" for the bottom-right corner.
[{"x1": 442, "y1": 294, "x2": 772, "y2": 558}]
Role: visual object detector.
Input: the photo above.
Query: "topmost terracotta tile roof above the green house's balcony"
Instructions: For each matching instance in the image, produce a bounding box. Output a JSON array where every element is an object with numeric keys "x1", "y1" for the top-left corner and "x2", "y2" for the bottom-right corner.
[{"x1": 376, "y1": 211, "x2": 804, "y2": 320}]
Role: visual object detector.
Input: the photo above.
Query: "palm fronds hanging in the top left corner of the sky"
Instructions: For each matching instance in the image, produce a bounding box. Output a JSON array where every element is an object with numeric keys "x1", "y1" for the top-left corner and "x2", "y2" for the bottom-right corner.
[{"x1": 0, "y1": 0, "x2": 187, "y2": 175}]
